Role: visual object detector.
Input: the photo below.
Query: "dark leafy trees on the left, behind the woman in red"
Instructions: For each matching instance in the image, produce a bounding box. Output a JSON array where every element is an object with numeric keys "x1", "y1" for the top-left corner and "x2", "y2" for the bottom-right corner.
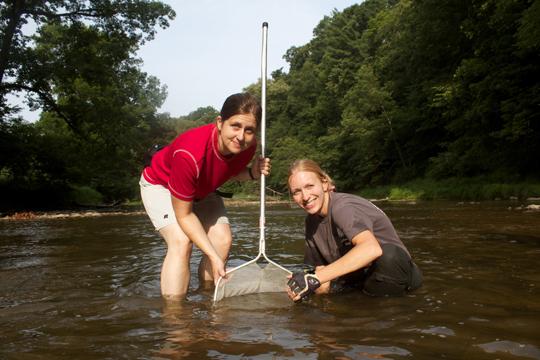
[{"x1": 0, "y1": 0, "x2": 174, "y2": 207}]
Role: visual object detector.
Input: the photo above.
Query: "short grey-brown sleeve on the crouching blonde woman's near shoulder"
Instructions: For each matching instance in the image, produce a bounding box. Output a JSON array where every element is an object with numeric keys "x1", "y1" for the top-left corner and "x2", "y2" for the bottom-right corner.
[{"x1": 332, "y1": 200, "x2": 373, "y2": 241}]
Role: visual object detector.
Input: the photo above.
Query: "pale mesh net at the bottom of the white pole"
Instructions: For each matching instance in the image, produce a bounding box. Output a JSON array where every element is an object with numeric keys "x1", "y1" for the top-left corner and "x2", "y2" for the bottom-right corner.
[{"x1": 214, "y1": 261, "x2": 290, "y2": 301}]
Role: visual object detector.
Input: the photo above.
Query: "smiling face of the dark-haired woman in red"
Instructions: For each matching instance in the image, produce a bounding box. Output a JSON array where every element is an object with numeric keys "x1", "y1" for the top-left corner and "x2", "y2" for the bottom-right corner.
[{"x1": 217, "y1": 114, "x2": 257, "y2": 155}]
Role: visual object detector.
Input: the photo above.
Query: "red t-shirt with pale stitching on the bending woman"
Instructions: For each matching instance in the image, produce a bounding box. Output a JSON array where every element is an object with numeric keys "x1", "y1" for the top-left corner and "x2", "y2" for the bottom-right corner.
[{"x1": 143, "y1": 124, "x2": 257, "y2": 201}]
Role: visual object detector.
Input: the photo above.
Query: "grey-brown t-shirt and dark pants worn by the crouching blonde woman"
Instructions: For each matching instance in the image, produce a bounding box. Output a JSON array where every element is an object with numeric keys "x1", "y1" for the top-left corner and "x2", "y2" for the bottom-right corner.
[{"x1": 304, "y1": 192, "x2": 422, "y2": 295}]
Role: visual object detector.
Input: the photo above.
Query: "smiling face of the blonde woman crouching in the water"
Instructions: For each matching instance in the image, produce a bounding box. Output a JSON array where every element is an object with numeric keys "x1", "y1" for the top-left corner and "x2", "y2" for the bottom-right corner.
[{"x1": 289, "y1": 171, "x2": 329, "y2": 216}]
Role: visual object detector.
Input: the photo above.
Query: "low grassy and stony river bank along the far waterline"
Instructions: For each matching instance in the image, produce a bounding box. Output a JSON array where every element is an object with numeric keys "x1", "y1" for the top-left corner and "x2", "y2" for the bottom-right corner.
[{"x1": 4, "y1": 178, "x2": 540, "y2": 220}]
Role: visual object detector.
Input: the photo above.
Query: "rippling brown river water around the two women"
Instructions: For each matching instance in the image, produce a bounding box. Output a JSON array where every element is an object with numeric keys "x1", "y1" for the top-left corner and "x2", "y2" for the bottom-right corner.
[{"x1": 0, "y1": 202, "x2": 540, "y2": 359}]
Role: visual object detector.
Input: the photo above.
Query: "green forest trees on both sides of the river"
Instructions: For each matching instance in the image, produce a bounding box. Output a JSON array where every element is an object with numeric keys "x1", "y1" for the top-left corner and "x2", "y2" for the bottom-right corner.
[{"x1": 0, "y1": 0, "x2": 540, "y2": 210}]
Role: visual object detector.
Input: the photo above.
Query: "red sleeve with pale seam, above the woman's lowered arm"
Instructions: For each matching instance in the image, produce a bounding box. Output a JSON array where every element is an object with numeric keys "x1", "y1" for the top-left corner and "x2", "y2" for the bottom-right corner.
[{"x1": 169, "y1": 150, "x2": 199, "y2": 201}]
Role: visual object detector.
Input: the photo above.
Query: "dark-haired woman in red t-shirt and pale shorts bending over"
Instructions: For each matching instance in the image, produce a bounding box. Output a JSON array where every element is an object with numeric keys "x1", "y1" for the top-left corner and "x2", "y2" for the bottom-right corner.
[{"x1": 140, "y1": 93, "x2": 270, "y2": 298}]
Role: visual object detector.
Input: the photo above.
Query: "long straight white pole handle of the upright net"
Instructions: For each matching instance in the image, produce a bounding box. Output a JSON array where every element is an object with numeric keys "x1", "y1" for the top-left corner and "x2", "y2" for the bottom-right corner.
[{"x1": 259, "y1": 22, "x2": 268, "y2": 257}]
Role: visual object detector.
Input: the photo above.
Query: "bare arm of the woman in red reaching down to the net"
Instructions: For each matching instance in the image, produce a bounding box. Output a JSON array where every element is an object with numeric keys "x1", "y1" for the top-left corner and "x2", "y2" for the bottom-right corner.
[{"x1": 171, "y1": 196, "x2": 225, "y2": 282}]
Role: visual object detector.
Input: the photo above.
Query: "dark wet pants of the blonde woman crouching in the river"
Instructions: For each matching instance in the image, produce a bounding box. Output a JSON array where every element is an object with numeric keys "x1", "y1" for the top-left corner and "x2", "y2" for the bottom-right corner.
[{"x1": 346, "y1": 244, "x2": 422, "y2": 296}]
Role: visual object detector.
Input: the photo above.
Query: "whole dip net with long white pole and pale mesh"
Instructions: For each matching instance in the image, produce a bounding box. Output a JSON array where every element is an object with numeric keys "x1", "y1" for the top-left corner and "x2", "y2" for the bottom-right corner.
[{"x1": 214, "y1": 22, "x2": 291, "y2": 302}]
